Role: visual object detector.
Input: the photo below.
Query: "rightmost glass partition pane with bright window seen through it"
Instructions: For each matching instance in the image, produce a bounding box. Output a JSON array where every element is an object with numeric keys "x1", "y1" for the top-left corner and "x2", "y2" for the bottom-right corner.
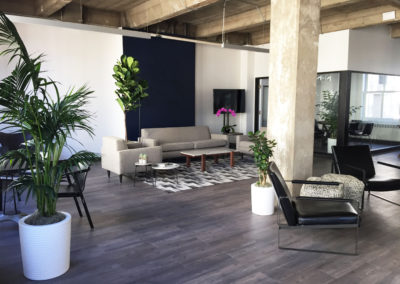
[{"x1": 348, "y1": 72, "x2": 400, "y2": 149}]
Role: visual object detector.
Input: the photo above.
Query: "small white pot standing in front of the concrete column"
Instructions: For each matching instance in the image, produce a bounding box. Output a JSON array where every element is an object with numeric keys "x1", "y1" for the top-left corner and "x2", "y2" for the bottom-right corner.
[{"x1": 251, "y1": 183, "x2": 275, "y2": 216}]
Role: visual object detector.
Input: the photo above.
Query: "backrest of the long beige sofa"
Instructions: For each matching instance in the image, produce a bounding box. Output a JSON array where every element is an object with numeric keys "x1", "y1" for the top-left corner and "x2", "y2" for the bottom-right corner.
[{"x1": 142, "y1": 126, "x2": 211, "y2": 145}]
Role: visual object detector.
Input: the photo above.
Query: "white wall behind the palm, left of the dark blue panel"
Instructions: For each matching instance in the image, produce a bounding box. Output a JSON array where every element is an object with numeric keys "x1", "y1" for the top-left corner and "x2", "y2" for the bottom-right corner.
[{"x1": 0, "y1": 23, "x2": 124, "y2": 156}]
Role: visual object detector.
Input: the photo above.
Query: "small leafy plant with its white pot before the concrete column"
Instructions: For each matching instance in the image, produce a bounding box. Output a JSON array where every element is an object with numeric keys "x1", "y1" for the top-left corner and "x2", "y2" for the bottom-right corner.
[{"x1": 249, "y1": 131, "x2": 276, "y2": 215}]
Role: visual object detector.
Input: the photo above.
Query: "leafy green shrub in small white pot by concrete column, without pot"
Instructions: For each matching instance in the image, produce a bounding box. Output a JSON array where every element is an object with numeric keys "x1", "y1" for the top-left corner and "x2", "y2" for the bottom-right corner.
[{"x1": 249, "y1": 131, "x2": 276, "y2": 187}]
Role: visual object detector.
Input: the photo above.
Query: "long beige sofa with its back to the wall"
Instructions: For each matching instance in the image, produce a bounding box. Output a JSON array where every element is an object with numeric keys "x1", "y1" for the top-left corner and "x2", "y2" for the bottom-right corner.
[{"x1": 140, "y1": 126, "x2": 228, "y2": 159}]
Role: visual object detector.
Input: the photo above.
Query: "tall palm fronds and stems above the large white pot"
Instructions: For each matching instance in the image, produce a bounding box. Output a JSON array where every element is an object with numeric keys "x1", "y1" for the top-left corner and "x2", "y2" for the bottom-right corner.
[{"x1": 0, "y1": 12, "x2": 98, "y2": 221}]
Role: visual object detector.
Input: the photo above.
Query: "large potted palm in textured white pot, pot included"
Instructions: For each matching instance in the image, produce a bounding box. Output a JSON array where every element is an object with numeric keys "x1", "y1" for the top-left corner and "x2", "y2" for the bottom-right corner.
[{"x1": 0, "y1": 12, "x2": 98, "y2": 280}]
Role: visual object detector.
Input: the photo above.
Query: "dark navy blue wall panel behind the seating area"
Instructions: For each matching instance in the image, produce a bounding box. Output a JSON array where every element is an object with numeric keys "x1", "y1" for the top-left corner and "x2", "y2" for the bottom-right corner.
[{"x1": 123, "y1": 37, "x2": 195, "y2": 140}]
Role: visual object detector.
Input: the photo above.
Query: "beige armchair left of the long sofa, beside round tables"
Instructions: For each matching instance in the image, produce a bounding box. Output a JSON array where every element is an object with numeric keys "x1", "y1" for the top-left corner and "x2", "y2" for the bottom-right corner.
[{"x1": 101, "y1": 136, "x2": 162, "y2": 182}]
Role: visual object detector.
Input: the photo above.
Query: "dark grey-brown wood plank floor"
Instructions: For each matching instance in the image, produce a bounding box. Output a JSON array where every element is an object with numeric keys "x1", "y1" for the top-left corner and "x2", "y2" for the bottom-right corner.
[{"x1": 0, "y1": 153, "x2": 400, "y2": 284}]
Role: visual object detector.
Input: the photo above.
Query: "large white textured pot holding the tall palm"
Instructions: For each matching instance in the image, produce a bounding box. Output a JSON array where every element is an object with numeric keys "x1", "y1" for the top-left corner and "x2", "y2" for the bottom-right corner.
[{"x1": 18, "y1": 212, "x2": 71, "y2": 280}]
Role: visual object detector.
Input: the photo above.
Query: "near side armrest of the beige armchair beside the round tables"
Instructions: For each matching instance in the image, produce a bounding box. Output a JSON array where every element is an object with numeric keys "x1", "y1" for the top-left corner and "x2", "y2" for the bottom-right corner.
[{"x1": 118, "y1": 146, "x2": 162, "y2": 174}]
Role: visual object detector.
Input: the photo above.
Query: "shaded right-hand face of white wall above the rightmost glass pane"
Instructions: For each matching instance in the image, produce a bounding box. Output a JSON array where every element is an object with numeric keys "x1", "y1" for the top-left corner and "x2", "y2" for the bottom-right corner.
[{"x1": 348, "y1": 25, "x2": 400, "y2": 75}]
